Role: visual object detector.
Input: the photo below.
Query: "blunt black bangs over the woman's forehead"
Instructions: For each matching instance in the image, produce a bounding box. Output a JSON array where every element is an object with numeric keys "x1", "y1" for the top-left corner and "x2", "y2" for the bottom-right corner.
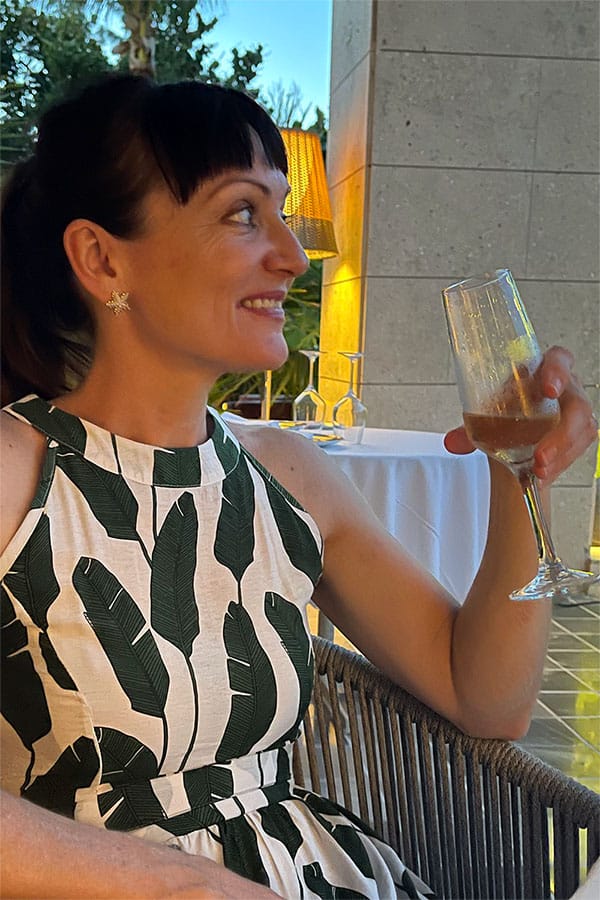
[{"x1": 141, "y1": 81, "x2": 287, "y2": 205}]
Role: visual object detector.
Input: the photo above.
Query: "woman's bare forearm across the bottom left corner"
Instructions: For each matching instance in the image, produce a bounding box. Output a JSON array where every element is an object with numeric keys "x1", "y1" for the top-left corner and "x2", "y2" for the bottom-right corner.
[{"x1": 0, "y1": 792, "x2": 278, "y2": 900}]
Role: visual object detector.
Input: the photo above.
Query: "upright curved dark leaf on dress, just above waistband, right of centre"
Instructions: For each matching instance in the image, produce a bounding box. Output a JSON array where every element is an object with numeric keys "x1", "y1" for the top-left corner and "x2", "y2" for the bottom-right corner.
[{"x1": 216, "y1": 601, "x2": 277, "y2": 762}]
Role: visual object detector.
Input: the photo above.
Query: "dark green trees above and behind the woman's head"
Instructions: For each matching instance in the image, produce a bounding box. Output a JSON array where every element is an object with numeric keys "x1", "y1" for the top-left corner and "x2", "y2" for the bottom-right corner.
[{"x1": 0, "y1": 0, "x2": 263, "y2": 167}]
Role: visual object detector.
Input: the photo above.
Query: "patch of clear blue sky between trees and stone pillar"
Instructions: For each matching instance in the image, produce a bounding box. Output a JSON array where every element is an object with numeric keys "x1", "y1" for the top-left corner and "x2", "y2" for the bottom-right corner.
[{"x1": 207, "y1": 0, "x2": 331, "y2": 117}]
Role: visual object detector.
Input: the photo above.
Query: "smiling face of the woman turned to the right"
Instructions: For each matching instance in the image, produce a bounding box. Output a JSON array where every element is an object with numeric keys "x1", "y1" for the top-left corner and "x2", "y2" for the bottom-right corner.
[{"x1": 114, "y1": 150, "x2": 307, "y2": 378}]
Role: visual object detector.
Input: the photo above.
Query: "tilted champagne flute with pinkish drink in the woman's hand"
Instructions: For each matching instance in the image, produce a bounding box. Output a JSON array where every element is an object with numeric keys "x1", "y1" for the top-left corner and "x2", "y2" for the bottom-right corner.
[{"x1": 442, "y1": 269, "x2": 599, "y2": 606}]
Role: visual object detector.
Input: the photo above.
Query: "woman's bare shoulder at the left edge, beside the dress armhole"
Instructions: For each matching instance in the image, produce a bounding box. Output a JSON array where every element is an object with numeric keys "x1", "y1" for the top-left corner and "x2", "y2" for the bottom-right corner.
[{"x1": 0, "y1": 412, "x2": 46, "y2": 552}]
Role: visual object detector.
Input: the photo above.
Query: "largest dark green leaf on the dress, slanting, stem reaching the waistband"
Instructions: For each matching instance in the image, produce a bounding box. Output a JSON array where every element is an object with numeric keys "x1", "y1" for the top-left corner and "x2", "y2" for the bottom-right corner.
[{"x1": 73, "y1": 557, "x2": 169, "y2": 768}]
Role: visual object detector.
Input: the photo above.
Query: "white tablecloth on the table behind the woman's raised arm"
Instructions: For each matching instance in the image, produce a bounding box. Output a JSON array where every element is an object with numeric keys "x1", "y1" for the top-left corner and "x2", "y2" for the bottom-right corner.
[{"x1": 320, "y1": 428, "x2": 489, "y2": 601}]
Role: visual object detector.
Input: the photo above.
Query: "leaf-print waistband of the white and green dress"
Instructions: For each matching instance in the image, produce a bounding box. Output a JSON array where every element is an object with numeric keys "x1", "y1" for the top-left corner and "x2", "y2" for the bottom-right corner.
[{"x1": 75, "y1": 743, "x2": 292, "y2": 834}]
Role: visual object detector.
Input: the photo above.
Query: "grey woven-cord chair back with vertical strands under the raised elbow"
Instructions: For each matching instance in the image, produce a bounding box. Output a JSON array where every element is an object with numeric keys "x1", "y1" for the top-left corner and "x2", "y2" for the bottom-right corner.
[{"x1": 294, "y1": 637, "x2": 600, "y2": 900}]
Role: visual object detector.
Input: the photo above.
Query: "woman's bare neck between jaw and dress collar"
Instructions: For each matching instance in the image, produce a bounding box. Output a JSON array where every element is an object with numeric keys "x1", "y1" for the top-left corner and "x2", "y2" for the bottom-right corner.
[{"x1": 55, "y1": 367, "x2": 210, "y2": 447}]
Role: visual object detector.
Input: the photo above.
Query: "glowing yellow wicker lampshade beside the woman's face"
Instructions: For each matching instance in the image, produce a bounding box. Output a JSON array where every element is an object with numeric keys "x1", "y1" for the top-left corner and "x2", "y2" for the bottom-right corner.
[{"x1": 281, "y1": 128, "x2": 338, "y2": 259}]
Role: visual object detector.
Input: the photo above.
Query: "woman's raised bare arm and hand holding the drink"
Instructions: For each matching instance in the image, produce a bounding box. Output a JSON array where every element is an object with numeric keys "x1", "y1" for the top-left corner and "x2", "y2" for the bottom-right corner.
[{"x1": 242, "y1": 350, "x2": 597, "y2": 739}]
